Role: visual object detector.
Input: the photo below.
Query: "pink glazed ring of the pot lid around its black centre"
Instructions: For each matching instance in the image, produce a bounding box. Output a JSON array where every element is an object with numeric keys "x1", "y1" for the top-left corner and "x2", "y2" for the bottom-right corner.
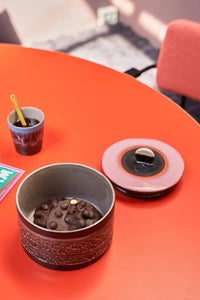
[{"x1": 102, "y1": 139, "x2": 184, "y2": 194}]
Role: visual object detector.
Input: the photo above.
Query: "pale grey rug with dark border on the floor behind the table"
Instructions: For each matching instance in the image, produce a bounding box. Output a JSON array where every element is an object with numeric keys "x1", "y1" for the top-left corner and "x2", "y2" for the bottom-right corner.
[{"x1": 31, "y1": 23, "x2": 200, "y2": 123}]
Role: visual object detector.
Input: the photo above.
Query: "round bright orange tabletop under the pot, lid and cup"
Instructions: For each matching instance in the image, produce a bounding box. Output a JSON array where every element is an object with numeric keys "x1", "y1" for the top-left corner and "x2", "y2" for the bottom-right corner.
[{"x1": 0, "y1": 44, "x2": 200, "y2": 300}]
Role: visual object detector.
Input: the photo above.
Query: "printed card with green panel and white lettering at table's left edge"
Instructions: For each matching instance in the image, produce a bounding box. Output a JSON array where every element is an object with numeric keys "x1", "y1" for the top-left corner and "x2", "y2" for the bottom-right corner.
[{"x1": 0, "y1": 163, "x2": 25, "y2": 201}]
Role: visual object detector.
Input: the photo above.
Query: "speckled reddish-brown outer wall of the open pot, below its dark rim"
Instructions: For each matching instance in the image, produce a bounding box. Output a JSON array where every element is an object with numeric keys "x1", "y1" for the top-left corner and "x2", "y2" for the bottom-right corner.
[{"x1": 19, "y1": 211, "x2": 114, "y2": 270}]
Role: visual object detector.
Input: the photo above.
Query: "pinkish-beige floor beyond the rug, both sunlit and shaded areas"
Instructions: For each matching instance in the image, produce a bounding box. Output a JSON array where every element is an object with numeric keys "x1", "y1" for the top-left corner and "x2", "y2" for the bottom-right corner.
[{"x1": 0, "y1": 0, "x2": 200, "y2": 47}]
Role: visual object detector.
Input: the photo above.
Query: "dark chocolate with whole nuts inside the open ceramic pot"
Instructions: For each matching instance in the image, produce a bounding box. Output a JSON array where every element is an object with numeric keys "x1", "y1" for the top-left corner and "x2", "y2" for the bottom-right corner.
[{"x1": 34, "y1": 198, "x2": 102, "y2": 231}]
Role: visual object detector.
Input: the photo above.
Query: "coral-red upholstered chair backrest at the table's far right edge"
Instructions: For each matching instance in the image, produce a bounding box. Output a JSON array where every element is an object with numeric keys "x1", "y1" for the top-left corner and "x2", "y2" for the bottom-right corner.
[{"x1": 156, "y1": 20, "x2": 200, "y2": 101}]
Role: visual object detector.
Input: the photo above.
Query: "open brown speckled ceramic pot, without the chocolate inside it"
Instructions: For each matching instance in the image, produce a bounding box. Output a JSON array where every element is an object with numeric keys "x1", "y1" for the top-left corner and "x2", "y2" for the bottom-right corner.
[{"x1": 16, "y1": 163, "x2": 115, "y2": 270}]
